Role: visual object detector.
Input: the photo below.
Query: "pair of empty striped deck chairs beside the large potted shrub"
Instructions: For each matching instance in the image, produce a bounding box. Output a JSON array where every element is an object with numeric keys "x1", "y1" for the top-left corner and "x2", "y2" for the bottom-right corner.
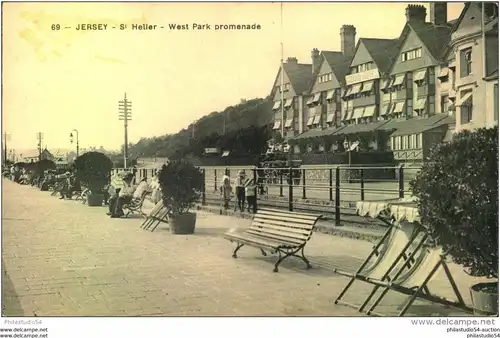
[{"x1": 334, "y1": 215, "x2": 472, "y2": 316}]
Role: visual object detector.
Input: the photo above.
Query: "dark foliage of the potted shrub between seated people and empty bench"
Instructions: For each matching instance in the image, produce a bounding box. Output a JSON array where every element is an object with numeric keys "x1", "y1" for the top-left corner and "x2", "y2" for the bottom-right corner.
[{"x1": 158, "y1": 160, "x2": 204, "y2": 214}]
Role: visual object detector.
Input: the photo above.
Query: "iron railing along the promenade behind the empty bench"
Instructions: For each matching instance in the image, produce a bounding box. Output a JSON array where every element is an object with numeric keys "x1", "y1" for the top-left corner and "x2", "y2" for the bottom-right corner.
[{"x1": 113, "y1": 165, "x2": 420, "y2": 225}]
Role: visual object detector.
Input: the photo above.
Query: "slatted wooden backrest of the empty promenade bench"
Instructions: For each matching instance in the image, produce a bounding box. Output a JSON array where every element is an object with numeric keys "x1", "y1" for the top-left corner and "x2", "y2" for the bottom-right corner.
[{"x1": 246, "y1": 208, "x2": 321, "y2": 245}]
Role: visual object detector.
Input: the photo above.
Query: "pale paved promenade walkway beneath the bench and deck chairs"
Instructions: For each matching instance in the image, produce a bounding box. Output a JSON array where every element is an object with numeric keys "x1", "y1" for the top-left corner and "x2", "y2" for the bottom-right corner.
[{"x1": 2, "y1": 180, "x2": 484, "y2": 316}]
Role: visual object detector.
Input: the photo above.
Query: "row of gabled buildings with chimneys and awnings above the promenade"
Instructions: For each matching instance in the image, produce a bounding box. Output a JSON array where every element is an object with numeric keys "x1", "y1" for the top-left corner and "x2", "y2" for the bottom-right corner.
[{"x1": 272, "y1": 2, "x2": 498, "y2": 164}]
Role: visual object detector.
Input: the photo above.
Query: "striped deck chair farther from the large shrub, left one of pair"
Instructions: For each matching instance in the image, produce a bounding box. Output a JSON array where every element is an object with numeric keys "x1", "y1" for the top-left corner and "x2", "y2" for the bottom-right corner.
[{"x1": 333, "y1": 223, "x2": 427, "y2": 312}]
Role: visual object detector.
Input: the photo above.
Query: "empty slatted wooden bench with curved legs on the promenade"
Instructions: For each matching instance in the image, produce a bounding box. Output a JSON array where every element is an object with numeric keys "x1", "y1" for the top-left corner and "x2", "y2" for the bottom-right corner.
[{"x1": 224, "y1": 208, "x2": 321, "y2": 272}]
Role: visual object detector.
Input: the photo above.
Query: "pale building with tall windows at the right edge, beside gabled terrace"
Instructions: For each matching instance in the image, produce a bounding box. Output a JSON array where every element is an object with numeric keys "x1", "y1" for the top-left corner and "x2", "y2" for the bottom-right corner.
[{"x1": 443, "y1": 2, "x2": 498, "y2": 132}]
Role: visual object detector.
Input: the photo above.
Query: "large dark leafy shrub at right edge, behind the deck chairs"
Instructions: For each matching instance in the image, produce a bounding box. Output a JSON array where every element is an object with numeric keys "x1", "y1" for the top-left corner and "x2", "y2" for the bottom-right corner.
[{"x1": 410, "y1": 127, "x2": 498, "y2": 278}]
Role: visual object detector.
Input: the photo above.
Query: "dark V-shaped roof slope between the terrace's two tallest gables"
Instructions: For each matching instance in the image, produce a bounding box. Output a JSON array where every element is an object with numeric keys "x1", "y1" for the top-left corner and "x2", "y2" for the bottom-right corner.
[{"x1": 356, "y1": 38, "x2": 401, "y2": 73}]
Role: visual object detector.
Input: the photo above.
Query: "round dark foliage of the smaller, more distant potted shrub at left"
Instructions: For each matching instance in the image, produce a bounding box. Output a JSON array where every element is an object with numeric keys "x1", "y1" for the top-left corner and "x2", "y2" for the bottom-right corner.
[{"x1": 74, "y1": 151, "x2": 113, "y2": 193}]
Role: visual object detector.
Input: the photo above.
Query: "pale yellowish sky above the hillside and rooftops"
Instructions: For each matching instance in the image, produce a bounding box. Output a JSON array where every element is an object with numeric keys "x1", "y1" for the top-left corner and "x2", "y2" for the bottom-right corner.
[{"x1": 2, "y1": 2, "x2": 463, "y2": 150}]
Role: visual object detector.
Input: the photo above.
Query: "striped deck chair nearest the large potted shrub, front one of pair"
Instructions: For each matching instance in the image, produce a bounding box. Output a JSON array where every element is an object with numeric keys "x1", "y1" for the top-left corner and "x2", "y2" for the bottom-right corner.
[{"x1": 367, "y1": 243, "x2": 473, "y2": 316}]
